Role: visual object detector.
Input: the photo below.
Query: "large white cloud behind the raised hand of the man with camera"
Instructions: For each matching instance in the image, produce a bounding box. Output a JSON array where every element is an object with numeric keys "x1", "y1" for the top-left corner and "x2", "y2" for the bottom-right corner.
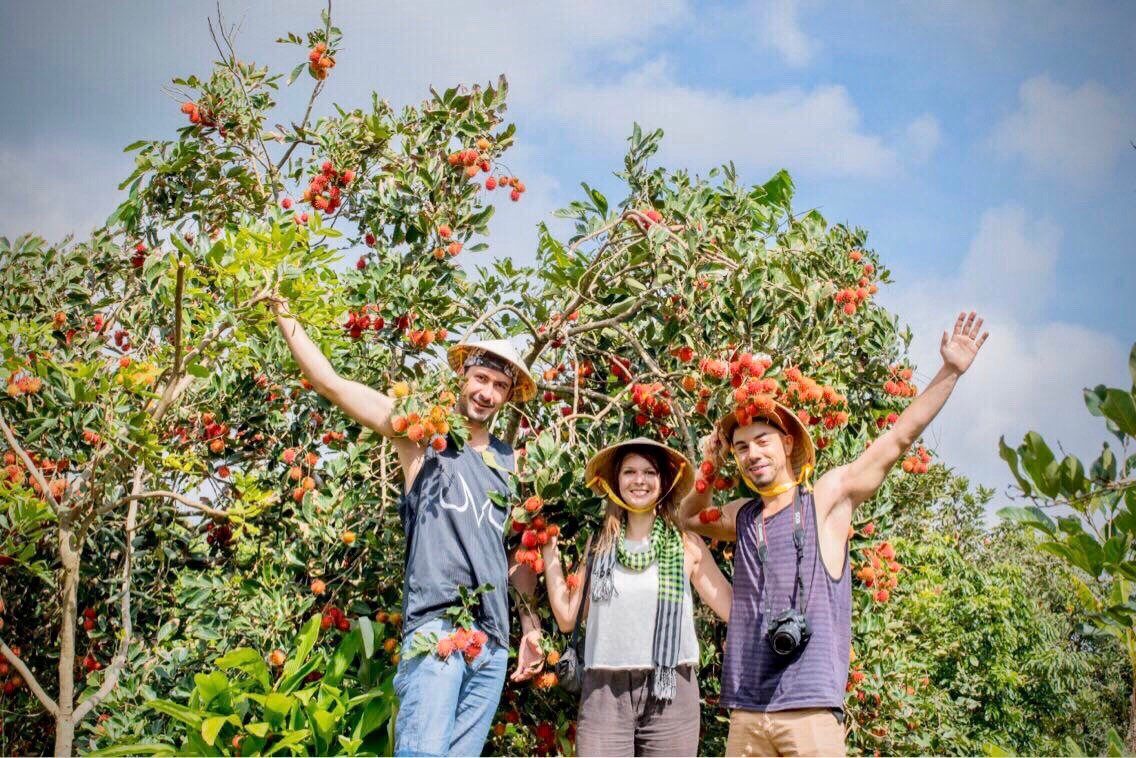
[{"x1": 884, "y1": 206, "x2": 1129, "y2": 491}]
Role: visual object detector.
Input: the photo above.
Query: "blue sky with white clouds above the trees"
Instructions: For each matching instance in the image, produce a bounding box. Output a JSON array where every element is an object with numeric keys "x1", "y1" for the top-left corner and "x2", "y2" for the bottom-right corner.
[{"x1": 0, "y1": 0, "x2": 1136, "y2": 493}]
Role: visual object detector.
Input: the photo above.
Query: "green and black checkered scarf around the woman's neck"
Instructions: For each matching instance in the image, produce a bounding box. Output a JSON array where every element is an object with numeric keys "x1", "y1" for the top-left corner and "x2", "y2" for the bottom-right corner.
[{"x1": 592, "y1": 516, "x2": 684, "y2": 700}]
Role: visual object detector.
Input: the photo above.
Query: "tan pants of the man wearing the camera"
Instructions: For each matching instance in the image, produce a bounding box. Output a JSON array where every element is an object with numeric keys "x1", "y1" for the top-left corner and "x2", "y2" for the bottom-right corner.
[{"x1": 726, "y1": 708, "x2": 845, "y2": 756}]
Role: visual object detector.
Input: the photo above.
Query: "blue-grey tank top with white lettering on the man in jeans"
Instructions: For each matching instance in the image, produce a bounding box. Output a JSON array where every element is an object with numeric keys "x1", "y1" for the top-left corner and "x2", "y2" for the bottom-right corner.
[{"x1": 399, "y1": 435, "x2": 513, "y2": 647}]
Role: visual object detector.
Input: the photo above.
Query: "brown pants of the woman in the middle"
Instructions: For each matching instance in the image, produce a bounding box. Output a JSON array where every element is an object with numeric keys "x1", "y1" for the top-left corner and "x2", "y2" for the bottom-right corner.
[{"x1": 576, "y1": 666, "x2": 701, "y2": 756}]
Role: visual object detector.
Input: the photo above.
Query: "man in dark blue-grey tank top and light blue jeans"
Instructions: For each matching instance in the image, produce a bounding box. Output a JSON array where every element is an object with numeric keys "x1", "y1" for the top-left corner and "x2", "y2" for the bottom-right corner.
[{"x1": 273, "y1": 300, "x2": 543, "y2": 756}]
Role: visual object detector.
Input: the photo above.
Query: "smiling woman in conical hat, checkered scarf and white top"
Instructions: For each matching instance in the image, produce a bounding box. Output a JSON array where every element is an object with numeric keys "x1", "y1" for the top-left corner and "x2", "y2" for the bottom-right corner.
[{"x1": 544, "y1": 438, "x2": 732, "y2": 756}]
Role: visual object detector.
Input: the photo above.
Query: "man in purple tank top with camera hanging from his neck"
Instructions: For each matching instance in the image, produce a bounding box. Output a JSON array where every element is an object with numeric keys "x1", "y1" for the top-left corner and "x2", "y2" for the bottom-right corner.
[{"x1": 682, "y1": 313, "x2": 987, "y2": 756}]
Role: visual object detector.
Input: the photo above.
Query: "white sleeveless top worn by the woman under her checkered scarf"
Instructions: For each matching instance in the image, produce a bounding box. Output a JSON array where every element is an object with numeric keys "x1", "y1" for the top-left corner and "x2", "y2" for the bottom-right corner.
[{"x1": 584, "y1": 540, "x2": 699, "y2": 669}]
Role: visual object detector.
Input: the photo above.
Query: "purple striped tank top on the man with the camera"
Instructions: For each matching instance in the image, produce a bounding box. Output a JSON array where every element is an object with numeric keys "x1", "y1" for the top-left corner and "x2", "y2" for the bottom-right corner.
[{"x1": 721, "y1": 491, "x2": 852, "y2": 711}]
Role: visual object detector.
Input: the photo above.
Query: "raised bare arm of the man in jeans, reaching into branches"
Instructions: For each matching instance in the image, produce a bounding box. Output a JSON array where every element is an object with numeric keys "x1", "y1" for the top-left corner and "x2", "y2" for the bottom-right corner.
[{"x1": 270, "y1": 299, "x2": 425, "y2": 489}]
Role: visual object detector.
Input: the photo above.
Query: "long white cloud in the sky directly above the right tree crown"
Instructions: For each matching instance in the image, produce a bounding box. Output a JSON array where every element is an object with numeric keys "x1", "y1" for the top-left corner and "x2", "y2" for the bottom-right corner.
[{"x1": 551, "y1": 58, "x2": 937, "y2": 177}]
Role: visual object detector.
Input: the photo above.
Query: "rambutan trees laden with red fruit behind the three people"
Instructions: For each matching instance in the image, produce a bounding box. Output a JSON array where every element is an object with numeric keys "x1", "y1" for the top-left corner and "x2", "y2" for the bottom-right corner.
[{"x1": 0, "y1": 7, "x2": 1122, "y2": 755}]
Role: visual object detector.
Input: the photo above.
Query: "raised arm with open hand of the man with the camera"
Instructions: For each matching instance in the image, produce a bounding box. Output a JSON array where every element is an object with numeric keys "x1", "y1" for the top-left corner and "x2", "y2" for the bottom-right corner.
[{"x1": 816, "y1": 311, "x2": 988, "y2": 523}]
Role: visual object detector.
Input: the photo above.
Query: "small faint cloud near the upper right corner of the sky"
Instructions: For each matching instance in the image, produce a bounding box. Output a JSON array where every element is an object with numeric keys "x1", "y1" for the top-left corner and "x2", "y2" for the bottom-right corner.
[{"x1": 991, "y1": 76, "x2": 1136, "y2": 183}]
